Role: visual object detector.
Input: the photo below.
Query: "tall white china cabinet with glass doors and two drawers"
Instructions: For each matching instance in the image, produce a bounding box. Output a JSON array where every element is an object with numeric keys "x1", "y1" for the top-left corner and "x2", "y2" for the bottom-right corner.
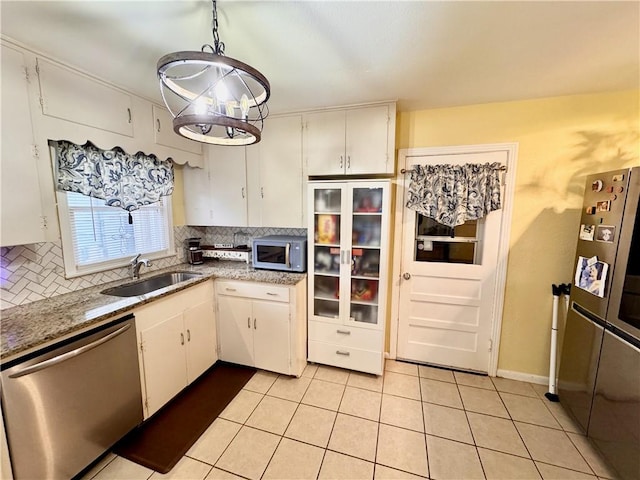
[{"x1": 308, "y1": 180, "x2": 391, "y2": 375}]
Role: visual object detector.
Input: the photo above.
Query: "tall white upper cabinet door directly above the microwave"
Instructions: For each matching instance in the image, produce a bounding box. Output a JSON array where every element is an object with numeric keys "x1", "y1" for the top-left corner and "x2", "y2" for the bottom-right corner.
[{"x1": 247, "y1": 115, "x2": 305, "y2": 228}]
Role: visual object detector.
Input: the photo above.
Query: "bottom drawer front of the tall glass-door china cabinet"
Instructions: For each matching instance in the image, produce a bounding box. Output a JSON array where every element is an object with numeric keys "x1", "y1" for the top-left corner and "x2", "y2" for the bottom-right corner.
[{"x1": 309, "y1": 340, "x2": 383, "y2": 375}]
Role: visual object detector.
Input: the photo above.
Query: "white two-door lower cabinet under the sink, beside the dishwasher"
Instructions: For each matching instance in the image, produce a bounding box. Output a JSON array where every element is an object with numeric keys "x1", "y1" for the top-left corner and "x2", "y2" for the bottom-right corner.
[{"x1": 134, "y1": 281, "x2": 218, "y2": 419}]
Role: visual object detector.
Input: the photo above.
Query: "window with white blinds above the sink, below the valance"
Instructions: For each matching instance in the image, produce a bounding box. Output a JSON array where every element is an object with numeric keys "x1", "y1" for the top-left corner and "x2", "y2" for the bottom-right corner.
[{"x1": 57, "y1": 192, "x2": 174, "y2": 277}]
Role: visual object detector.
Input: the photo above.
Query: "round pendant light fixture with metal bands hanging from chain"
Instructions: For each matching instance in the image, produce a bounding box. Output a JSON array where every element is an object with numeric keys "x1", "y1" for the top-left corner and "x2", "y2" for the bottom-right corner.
[{"x1": 158, "y1": 0, "x2": 270, "y2": 145}]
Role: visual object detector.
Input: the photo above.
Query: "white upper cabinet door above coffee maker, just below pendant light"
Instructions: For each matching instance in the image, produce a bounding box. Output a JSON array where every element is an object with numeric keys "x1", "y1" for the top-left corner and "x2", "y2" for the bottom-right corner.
[{"x1": 208, "y1": 146, "x2": 247, "y2": 227}]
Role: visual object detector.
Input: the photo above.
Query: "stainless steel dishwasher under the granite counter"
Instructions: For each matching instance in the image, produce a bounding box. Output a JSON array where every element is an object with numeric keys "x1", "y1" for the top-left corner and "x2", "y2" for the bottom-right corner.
[{"x1": 1, "y1": 315, "x2": 142, "y2": 480}]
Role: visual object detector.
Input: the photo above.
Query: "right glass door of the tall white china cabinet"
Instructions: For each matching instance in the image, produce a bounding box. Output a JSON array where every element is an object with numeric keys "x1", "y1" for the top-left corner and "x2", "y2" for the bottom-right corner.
[{"x1": 348, "y1": 187, "x2": 383, "y2": 324}]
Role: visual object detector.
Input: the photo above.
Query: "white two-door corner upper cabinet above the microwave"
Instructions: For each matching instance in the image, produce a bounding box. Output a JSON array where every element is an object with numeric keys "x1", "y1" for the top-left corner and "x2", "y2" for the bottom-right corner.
[{"x1": 184, "y1": 115, "x2": 305, "y2": 228}]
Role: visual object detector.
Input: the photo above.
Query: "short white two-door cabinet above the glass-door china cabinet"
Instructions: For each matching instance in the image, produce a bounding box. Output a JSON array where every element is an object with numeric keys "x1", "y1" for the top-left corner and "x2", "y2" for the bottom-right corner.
[{"x1": 304, "y1": 103, "x2": 396, "y2": 176}]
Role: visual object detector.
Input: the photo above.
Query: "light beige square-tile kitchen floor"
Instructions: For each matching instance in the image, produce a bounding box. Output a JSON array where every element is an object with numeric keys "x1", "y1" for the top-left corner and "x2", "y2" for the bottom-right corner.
[{"x1": 84, "y1": 360, "x2": 614, "y2": 480}]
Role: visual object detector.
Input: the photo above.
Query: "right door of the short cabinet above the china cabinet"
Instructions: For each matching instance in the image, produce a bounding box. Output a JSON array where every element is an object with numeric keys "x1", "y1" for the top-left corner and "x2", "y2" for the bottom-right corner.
[{"x1": 346, "y1": 105, "x2": 395, "y2": 175}]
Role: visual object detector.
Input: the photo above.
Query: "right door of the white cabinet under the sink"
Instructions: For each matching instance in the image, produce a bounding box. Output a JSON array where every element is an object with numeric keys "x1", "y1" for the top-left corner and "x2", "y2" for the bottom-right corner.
[{"x1": 184, "y1": 299, "x2": 218, "y2": 383}]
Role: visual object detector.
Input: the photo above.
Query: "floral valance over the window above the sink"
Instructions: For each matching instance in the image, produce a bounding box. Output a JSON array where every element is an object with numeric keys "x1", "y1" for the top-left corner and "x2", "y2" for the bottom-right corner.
[{"x1": 56, "y1": 141, "x2": 173, "y2": 212}]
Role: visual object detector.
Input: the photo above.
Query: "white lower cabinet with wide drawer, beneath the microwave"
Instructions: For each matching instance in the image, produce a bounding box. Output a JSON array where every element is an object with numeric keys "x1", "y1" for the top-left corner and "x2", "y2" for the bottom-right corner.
[{"x1": 216, "y1": 280, "x2": 307, "y2": 377}]
